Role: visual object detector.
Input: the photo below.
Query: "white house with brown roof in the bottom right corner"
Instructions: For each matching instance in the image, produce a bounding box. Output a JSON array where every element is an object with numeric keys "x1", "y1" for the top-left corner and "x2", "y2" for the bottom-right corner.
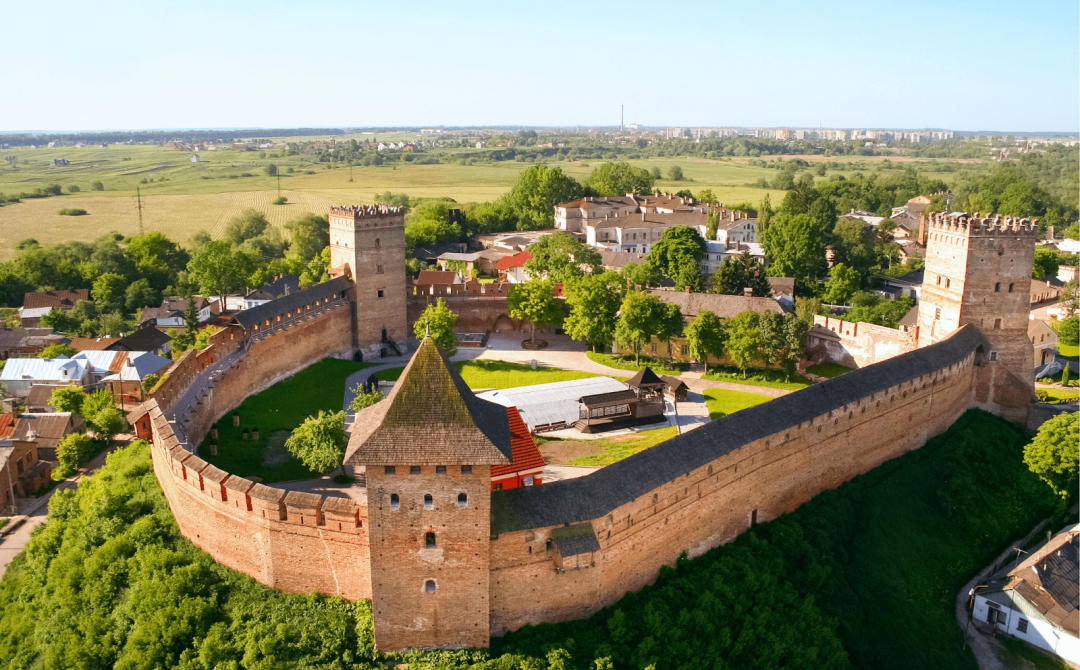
[{"x1": 971, "y1": 525, "x2": 1080, "y2": 665}]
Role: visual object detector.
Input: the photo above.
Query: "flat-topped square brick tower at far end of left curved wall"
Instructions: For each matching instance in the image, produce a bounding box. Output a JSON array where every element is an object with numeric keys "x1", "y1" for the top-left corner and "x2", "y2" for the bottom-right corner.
[{"x1": 329, "y1": 205, "x2": 408, "y2": 359}]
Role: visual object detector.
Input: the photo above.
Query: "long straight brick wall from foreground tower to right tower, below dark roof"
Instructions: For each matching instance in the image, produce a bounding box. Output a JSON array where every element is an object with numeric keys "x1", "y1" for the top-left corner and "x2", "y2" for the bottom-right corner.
[{"x1": 490, "y1": 343, "x2": 974, "y2": 635}]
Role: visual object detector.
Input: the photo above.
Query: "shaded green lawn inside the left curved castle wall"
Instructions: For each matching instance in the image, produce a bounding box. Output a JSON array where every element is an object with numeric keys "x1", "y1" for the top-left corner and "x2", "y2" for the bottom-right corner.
[{"x1": 199, "y1": 359, "x2": 370, "y2": 483}]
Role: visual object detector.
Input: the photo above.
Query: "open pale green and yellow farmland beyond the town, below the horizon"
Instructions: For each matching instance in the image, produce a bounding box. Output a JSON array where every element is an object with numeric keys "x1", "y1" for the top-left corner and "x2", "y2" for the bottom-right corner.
[{"x1": 0, "y1": 142, "x2": 980, "y2": 262}]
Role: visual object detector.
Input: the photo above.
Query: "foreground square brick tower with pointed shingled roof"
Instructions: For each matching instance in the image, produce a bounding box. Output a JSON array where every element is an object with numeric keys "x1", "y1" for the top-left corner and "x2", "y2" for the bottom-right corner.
[{"x1": 346, "y1": 337, "x2": 512, "y2": 651}]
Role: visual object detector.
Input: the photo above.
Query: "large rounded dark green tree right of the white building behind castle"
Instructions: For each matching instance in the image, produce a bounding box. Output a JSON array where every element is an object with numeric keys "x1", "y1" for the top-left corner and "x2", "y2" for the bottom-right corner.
[{"x1": 761, "y1": 210, "x2": 828, "y2": 294}]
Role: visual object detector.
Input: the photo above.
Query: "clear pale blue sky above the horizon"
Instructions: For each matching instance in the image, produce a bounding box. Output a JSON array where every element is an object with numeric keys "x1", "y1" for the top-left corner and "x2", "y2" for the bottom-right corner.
[{"x1": 0, "y1": 0, "x2": 1080, "y2": 131}]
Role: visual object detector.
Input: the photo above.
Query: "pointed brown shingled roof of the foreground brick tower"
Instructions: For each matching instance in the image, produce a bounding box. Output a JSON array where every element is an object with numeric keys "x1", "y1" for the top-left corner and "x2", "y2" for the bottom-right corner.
[{"x1": 346, "y1": 337, "x2": 513, "y2": 466}]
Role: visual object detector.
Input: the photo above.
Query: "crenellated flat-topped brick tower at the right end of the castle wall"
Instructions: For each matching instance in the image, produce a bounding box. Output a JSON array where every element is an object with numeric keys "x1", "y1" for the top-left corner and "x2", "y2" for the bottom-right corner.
[{"x1": 919, "y1": 213, "x2": 1039, "y2": 421}]
